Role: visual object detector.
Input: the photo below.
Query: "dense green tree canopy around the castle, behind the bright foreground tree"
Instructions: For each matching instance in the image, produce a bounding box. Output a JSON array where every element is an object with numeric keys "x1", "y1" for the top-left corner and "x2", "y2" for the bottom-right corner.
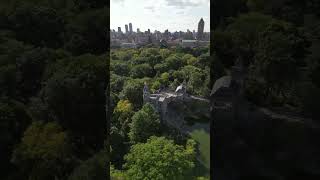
[{"x1": 110, "y1": 47, "x2": 211, "y2": 179}]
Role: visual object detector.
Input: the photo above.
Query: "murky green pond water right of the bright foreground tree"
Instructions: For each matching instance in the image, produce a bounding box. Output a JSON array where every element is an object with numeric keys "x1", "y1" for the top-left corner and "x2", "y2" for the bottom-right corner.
[{"x1": 190, "y1": 129, "x2": 210, "y2": 173}]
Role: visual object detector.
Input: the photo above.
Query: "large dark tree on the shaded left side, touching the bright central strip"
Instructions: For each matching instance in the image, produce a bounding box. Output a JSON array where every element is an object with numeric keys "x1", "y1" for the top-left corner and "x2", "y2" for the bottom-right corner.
[{"x1": 40, "y1": 55, "x2": 107, "y2": 151}]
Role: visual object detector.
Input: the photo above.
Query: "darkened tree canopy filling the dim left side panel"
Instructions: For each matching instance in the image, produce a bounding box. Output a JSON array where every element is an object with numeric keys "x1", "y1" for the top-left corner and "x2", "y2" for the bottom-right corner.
[{"x1": 0, "y1": 0, "x2": 109, "y2": 180}]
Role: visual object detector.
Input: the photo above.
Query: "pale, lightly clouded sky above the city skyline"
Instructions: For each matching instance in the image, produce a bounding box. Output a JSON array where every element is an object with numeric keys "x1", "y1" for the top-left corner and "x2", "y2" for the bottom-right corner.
[{"x1": 110, "y1": 0, "x2": 210, "y2": 32}]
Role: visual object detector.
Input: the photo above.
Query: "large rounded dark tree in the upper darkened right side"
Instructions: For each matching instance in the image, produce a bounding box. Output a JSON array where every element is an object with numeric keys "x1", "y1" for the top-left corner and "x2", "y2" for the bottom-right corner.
[{"x1": 254, "y1": 21, "x2": 309, "y2": 101}]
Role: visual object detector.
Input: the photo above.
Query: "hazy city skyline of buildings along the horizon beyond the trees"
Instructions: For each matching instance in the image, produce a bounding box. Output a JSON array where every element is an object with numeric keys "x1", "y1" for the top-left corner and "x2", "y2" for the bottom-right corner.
[{"x1": 110, "y1": 18, "x2": 210, "y2": 48}]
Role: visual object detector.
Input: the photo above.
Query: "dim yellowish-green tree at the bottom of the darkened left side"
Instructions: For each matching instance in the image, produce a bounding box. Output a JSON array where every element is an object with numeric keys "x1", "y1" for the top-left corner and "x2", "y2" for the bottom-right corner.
[{"x1": 12, "y1": 121, "x2": 73, "y2": 179}]
